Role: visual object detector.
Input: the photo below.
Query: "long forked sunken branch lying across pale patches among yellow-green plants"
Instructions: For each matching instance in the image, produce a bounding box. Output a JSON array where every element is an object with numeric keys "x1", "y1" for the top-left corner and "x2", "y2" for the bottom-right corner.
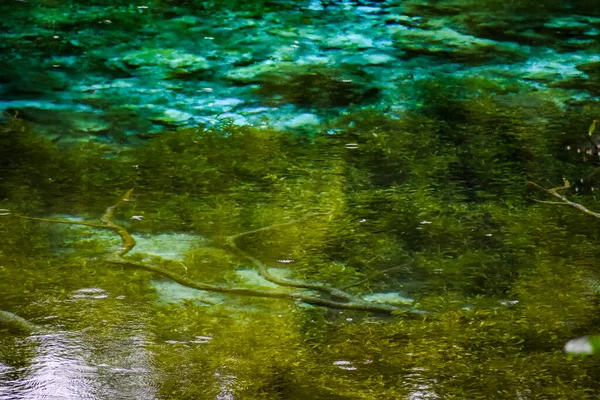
[{"x1": 3, "y1": 189, "x2": 423, "y2": 315}]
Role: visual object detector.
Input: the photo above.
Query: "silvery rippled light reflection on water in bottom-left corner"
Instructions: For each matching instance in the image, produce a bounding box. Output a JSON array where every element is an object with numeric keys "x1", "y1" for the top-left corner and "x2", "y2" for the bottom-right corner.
[{"x1": 0, "y1": 332, "x2": 157, "y2": 400}]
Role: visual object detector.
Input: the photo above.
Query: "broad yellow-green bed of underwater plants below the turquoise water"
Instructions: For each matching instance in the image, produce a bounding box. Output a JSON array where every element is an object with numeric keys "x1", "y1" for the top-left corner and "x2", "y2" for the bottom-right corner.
[{"x1": 0, "y1": 76, "x2": 600, "y2": 399}]
